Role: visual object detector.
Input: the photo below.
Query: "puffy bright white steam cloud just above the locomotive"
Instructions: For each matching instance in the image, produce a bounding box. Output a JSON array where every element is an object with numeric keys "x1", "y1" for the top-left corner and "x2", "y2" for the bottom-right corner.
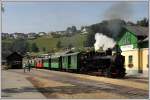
[{"x1": 94, "y1": 33, "x2": 116, "y2": 51}]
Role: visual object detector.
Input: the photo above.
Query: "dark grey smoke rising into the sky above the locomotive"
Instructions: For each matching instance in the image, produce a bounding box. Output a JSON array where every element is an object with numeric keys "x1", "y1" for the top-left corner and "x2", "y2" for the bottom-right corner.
[{"x1": 104, "y1": 1, "x2": 133, "y2": 38}]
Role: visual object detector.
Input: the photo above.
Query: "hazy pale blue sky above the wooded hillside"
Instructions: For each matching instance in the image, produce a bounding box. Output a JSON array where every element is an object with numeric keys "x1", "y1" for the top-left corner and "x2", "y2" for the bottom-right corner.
[{"x1": 2, "y1": 1, "x2": 148, "y2": 33}]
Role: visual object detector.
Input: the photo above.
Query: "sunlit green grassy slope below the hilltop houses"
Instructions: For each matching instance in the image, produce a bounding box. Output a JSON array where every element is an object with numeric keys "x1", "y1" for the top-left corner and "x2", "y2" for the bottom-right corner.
[{"x1": 2, "y1": 34, "x2": 86, "y2": 51}]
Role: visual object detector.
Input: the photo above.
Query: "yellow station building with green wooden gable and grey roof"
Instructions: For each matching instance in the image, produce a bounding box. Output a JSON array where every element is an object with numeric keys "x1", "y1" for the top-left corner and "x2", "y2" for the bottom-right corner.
[{"x1": 117, "y1": 25, "x2": 149, "y2": 77}]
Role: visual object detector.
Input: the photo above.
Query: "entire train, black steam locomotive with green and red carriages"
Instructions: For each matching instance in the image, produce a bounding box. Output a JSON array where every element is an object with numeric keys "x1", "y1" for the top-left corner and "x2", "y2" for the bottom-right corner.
[{"x1": 27, "y1": 45, "x2": 126, "y2": 78}]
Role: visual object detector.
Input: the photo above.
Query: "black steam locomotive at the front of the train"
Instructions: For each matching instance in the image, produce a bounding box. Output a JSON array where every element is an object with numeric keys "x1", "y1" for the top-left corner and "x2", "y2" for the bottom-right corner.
[{"x1": 80, "y1": 45, "x2": 126, "y2": 78}]
